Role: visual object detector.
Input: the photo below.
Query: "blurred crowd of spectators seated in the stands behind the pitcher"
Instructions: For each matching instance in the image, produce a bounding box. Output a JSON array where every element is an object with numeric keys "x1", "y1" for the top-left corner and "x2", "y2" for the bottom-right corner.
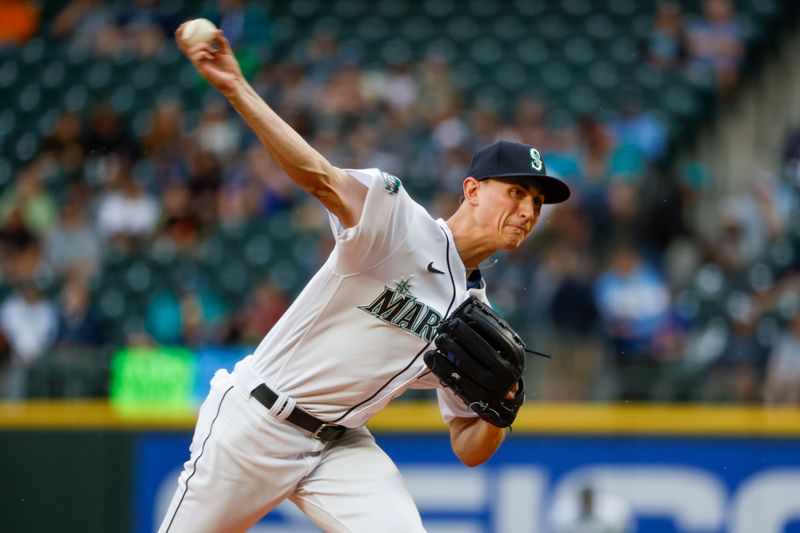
[{"x1": 0, "y1": 0, "x2": 800, "y2": 404}]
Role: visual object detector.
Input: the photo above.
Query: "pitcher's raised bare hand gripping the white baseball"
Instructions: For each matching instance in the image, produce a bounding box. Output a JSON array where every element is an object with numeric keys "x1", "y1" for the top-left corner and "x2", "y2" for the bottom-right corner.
[{"x1": 175, "y1": 23, "x2": 243, "y2": 95}]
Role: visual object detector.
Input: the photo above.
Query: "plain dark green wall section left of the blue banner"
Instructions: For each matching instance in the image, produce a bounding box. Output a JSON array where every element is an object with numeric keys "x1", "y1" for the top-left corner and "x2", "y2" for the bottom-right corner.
[{"x1": 0, "y1": 431, "x2": 135, "y2": 533}]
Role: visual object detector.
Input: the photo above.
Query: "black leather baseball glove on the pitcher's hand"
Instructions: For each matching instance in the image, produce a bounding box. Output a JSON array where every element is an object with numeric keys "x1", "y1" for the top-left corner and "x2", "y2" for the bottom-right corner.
[{"x1": 424, "y1": 296, "x2": 544, "y2": 427}]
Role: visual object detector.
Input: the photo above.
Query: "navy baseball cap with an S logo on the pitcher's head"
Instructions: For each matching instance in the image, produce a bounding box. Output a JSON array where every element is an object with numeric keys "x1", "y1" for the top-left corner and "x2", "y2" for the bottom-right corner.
[{"x1": 467, "y1": 141, "x2": 570, "y2": 204}]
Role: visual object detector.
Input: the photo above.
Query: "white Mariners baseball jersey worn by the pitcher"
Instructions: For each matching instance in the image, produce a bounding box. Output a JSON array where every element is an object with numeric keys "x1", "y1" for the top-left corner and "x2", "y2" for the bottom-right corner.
[{"x1": 233, "y1": 169, "x2": 485, "y2": 427}]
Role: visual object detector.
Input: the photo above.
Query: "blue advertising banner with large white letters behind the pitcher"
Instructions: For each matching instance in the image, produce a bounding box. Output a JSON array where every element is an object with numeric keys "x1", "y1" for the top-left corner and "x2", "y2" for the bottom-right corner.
[{"x1": 134, "y1": 433, "x2": 800, "y2": 533}]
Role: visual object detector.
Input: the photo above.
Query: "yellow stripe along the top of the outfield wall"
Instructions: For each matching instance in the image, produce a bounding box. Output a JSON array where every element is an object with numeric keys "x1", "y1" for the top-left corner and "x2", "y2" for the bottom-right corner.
[{"x1": 0, "y1": 401, "x2": 800, "y2": 438}]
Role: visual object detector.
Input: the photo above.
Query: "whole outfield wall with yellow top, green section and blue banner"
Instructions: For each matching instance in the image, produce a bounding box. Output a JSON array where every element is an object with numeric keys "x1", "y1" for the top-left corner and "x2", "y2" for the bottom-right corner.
[{"x1": 0, "y1": 403, "x2": 800, "y2": 533}]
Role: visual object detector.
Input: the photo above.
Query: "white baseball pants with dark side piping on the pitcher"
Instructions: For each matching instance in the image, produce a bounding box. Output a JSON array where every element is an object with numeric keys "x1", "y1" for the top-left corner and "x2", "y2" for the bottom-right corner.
[{"x1": 159, "y1": 370, "x2": 425, "y2": 533}]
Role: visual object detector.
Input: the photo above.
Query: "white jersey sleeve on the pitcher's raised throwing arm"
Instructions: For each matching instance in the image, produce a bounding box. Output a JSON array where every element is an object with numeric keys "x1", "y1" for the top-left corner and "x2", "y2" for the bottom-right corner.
[{"x1": 328, "y1": 169, "x2": 417, "y2": 275}]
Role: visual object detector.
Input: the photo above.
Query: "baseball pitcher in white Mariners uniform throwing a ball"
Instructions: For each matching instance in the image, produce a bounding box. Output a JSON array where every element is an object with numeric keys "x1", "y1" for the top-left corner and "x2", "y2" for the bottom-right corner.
[{"x1": 160, "y1": 26, "x2": 570, "y2": 533}]
